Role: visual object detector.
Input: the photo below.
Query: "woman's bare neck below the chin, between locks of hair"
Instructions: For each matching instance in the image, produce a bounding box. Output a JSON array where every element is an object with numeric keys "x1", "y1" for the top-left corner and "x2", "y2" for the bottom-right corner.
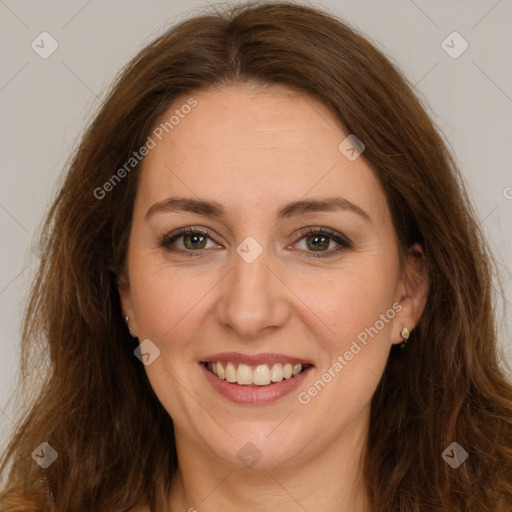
[{"x1": 171, "y1": 411, "x2": 370, "y2": 512}]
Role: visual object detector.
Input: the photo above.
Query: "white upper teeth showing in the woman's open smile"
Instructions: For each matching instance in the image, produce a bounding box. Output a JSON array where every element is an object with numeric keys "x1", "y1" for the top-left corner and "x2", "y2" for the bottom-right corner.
[{"x1": 207, "y1": 361, "x2": 302, "y2": 386}]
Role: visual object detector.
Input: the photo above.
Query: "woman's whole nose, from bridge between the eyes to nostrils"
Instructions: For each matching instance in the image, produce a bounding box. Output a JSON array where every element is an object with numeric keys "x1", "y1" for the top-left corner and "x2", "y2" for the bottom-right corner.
[{"x1": 218, "y1": 237, "x2": 288, "y2": 338}]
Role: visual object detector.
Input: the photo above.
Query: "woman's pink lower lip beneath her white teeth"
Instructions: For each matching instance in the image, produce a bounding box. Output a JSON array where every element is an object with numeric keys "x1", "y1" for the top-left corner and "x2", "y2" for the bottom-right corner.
[{"x1": 200, "y1": 363, "x2": 313, "y2": 405}]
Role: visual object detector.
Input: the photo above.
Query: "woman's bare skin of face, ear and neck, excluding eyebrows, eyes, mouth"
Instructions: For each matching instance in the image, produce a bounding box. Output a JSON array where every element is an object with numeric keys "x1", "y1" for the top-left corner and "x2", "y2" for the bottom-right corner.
[{"x1": 118, "y1": 84, "x2": 428, "y2": 512}]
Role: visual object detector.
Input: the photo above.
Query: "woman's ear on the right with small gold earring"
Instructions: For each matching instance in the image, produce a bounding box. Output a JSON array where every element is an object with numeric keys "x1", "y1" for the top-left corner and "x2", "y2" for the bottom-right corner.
[{"x1": 392, "y1": 243, "x2": 430, "y2": 344}]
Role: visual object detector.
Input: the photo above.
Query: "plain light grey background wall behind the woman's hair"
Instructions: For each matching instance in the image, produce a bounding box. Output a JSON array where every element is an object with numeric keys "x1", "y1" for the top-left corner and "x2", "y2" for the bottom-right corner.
[{"x1": 0, "y1": 0, "x2": 512, "y2": 456}]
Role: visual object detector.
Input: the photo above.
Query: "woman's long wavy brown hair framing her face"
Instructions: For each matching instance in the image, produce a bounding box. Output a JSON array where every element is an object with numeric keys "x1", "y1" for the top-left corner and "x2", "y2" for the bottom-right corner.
[{"x1": 0, "y1": 2, "x2": 512, "y2": 512}]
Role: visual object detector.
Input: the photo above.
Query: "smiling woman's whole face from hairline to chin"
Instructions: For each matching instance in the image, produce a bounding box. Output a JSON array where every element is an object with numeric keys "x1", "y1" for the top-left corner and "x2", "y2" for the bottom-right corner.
[{"x1": 119, "y1": 85, "x2": 422, "y2": 467}]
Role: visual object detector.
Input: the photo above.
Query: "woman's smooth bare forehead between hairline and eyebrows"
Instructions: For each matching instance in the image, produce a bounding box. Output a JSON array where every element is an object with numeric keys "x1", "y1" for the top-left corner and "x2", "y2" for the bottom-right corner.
[{"x1": 138, "y1": 85, "x2": 386, "y2": 219}]
